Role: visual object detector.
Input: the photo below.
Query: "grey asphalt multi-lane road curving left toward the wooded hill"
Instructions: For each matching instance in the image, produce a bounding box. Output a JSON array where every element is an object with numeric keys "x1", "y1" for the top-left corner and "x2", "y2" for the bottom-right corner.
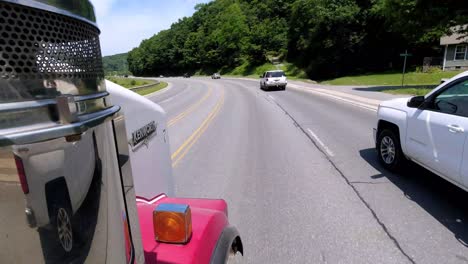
[{"x1": 147, "y1": 79, "x2": 468, "y2": 263}]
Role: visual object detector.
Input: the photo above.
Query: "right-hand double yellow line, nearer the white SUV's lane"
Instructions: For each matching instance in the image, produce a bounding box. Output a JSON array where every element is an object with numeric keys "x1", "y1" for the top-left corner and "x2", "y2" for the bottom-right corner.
[{"x1": 171, "y1": 90, "x2": 224, "y2": 167}]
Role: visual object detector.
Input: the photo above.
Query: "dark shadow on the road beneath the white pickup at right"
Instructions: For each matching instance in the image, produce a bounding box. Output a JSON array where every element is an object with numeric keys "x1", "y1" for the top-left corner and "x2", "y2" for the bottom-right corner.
[{"x1": 359, "y1": 148, "x2": 468, "y2": 247}]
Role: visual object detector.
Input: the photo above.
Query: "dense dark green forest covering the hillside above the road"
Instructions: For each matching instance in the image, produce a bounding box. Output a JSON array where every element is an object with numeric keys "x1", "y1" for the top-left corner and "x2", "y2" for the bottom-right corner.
[{"x1": 128, "y1": 0, "x2": 468, "y2": 79}]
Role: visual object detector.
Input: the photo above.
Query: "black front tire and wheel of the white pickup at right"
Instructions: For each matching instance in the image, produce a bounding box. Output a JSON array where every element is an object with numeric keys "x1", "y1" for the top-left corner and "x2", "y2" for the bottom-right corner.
[{"x1": 377, "y1": 129, "x2": 406, "y2": 172}]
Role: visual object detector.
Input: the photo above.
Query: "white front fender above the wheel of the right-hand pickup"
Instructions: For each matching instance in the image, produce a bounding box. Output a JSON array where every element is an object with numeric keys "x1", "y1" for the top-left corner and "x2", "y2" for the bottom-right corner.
[{"x1": 377, "y1": 107, "x2": 407, "y2": 155}]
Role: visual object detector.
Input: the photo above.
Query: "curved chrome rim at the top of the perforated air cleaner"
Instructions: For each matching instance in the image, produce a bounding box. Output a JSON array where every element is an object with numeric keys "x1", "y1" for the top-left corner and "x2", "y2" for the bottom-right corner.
[{"x1": 1, "y1": 0, "x2": 98, "y2": 28}]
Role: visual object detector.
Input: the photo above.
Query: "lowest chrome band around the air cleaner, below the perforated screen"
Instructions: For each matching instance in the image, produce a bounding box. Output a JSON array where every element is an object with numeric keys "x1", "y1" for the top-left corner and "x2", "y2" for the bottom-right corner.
[{"x1": 0, "y1": 106, "x2": 120, "y2": 147}]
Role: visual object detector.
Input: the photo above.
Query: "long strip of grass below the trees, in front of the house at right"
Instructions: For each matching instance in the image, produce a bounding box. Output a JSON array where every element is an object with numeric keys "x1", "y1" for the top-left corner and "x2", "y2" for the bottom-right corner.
[{"x1": 322, "y1": 71, "x2": 460, "y2": 86}]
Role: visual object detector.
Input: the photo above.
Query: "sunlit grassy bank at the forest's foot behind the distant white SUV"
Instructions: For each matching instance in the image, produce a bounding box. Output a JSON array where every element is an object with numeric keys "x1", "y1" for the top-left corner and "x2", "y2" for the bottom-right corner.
[{"x1": 221, "y1": 62, "x2": 307, "y2": 80}]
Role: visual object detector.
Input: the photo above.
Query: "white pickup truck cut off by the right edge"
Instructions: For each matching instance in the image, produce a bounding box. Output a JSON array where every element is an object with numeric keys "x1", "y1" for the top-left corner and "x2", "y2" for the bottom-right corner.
[{"x1": 374, "y1": 71, "x2": 468, "y2": 191}]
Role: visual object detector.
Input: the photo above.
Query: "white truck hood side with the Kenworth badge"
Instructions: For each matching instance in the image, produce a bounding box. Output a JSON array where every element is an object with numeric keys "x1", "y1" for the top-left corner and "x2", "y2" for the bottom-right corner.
[{"x1": 106, "y1": 81, "x2": 174, "y2": 199}]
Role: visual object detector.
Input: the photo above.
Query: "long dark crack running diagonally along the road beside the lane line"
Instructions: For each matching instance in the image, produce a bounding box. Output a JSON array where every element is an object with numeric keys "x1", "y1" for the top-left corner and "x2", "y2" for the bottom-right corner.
[{"x1": 273, "y1": 100, "x2": 416, "y2": 263}]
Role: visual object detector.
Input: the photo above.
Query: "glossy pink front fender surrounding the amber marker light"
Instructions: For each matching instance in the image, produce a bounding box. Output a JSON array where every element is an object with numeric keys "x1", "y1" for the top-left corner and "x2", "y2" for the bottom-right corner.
[{"x1": 137, "y1": 195, "x2": 242, "y2": 263}]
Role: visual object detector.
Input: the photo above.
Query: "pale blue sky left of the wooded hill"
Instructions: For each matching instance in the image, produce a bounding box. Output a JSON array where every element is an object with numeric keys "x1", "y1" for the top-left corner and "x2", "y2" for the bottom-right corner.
[{"x1": 91, "y1": 0, "x2": 210, "y2": 56}]
